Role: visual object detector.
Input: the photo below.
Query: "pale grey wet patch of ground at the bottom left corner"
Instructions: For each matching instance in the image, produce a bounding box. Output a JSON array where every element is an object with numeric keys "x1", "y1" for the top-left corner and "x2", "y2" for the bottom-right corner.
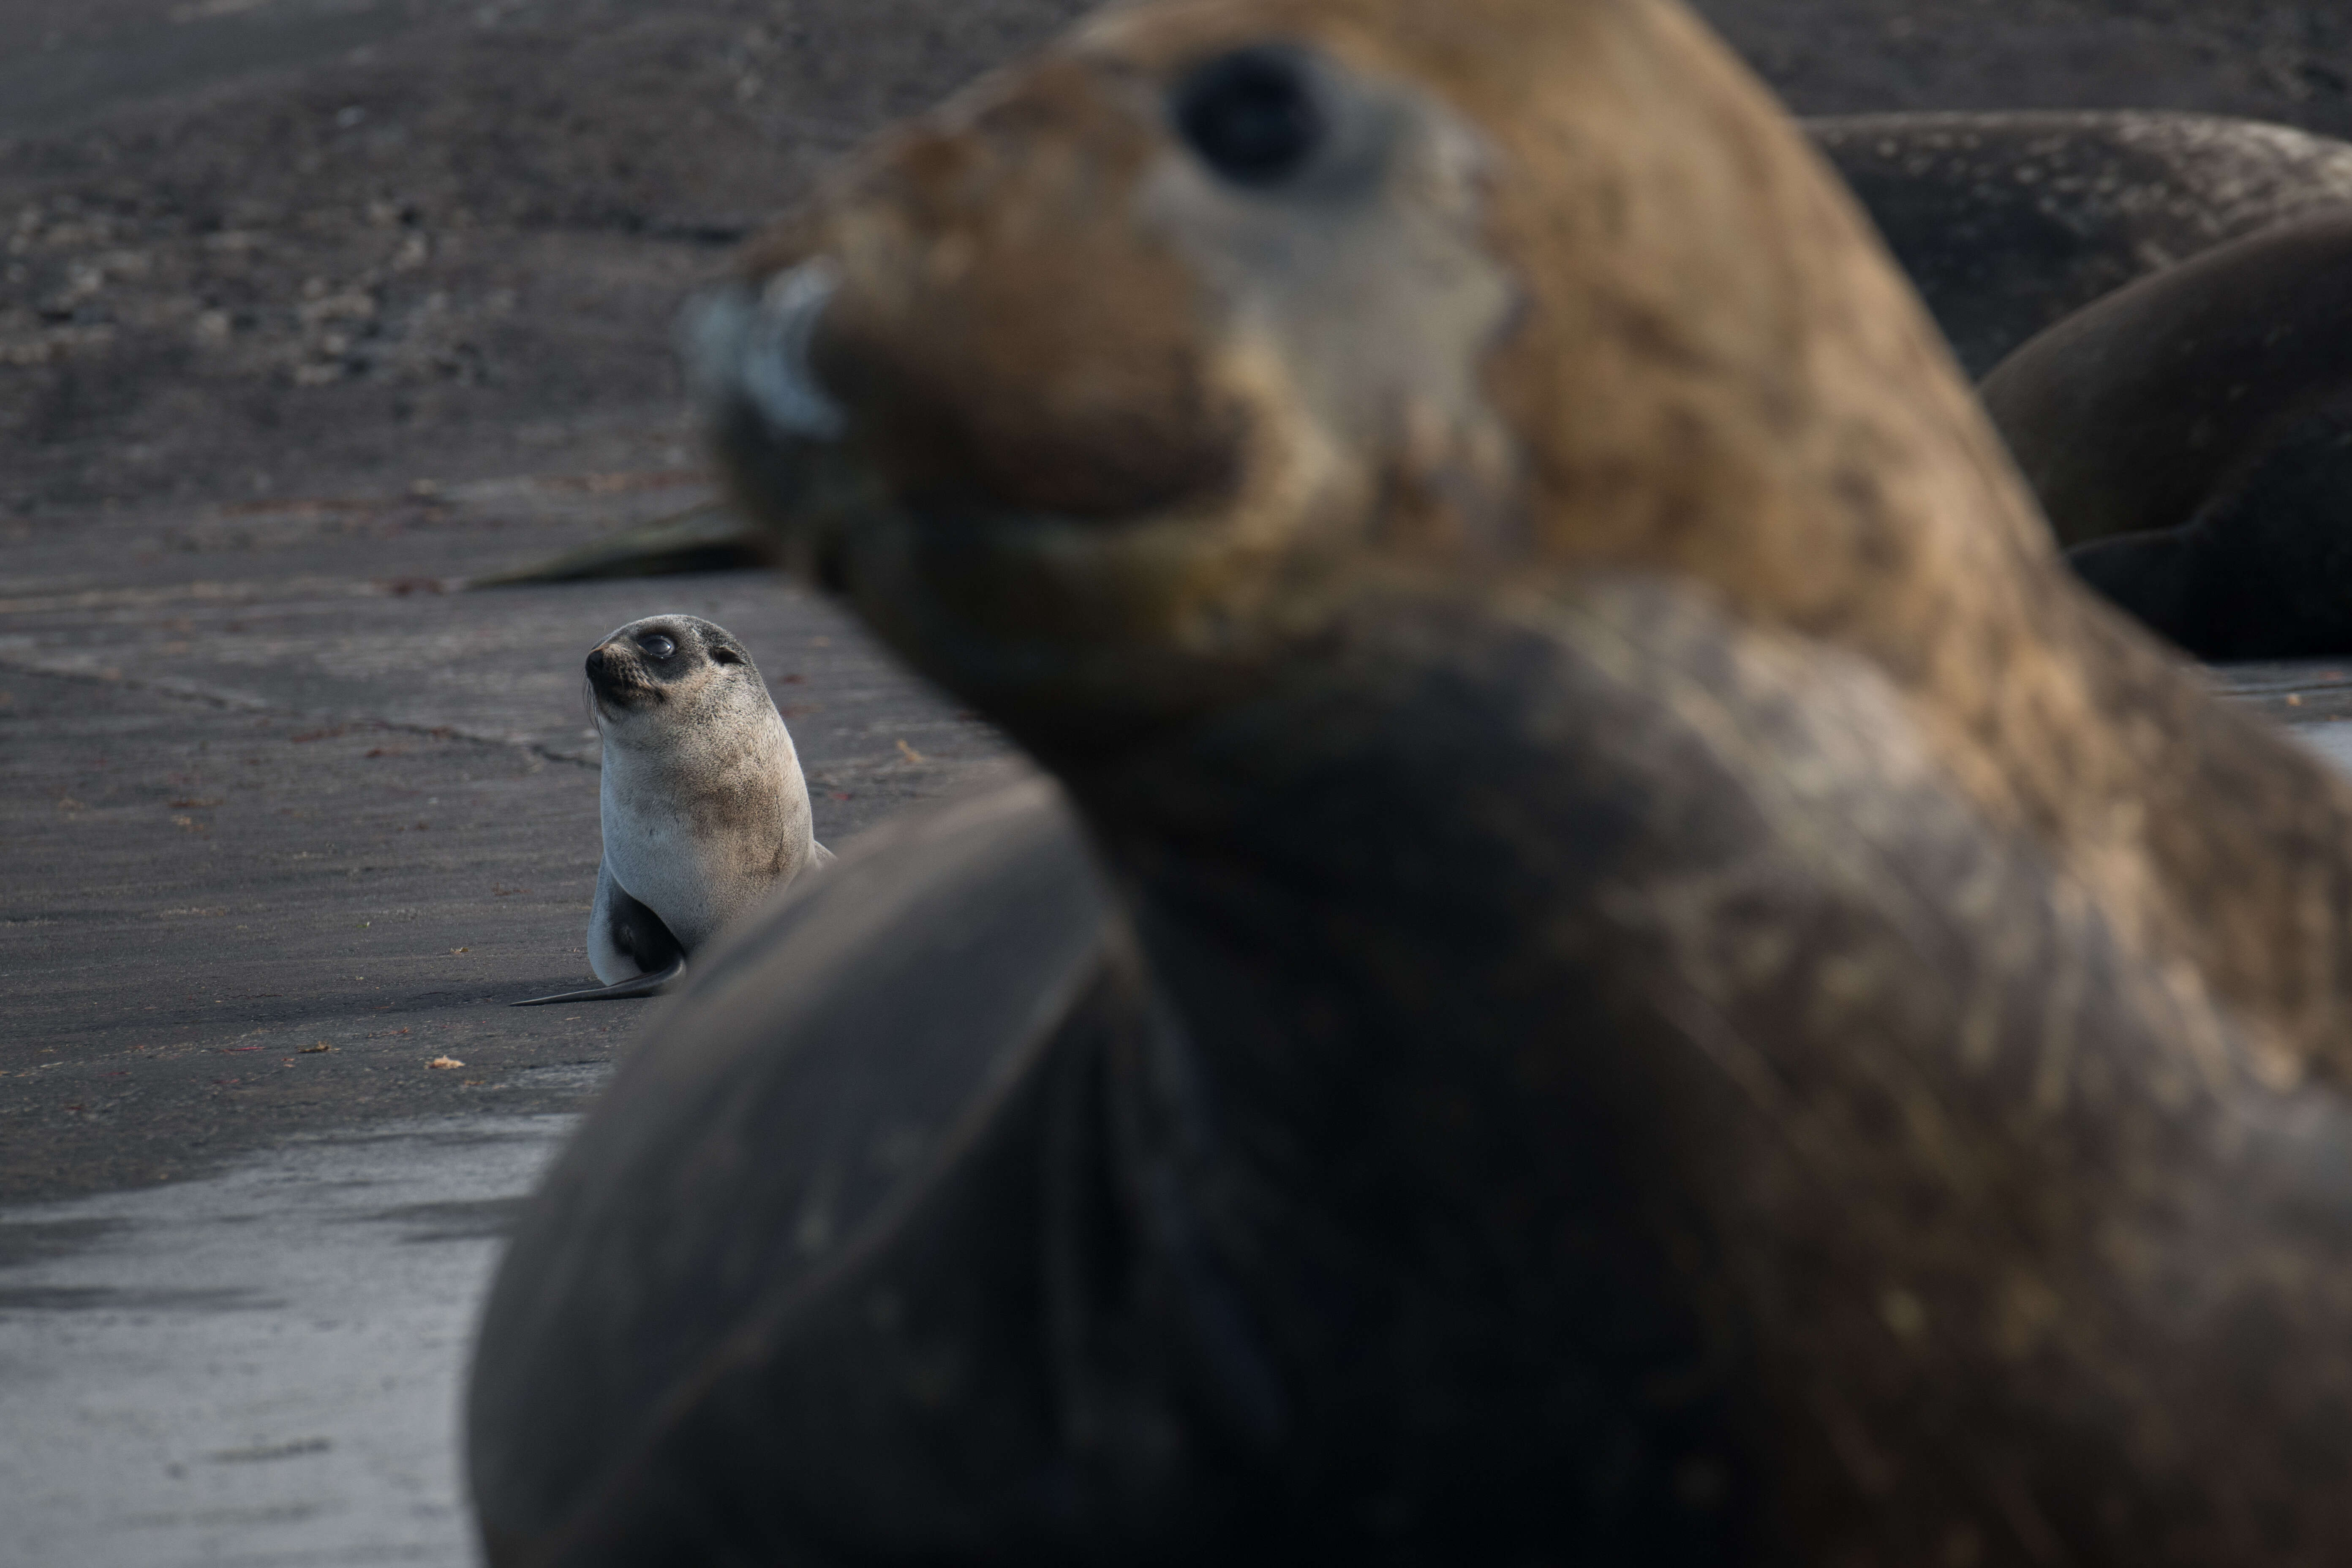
[{"x1": 0, "y1": 1105, "x2": 602, "y2": 1568}]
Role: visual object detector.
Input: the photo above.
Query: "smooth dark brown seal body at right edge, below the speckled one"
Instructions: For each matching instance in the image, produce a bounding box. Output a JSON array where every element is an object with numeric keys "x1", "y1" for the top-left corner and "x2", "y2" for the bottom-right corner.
[{"x1": 1980, "y1": 209, "x2": 2352, "y2": 658}]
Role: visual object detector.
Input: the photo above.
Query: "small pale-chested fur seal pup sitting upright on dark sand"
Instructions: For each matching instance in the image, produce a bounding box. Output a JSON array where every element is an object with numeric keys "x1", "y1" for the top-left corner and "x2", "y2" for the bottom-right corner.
[{"x1": 515, "y1": 614, "x2": 833, "y2": 1006}]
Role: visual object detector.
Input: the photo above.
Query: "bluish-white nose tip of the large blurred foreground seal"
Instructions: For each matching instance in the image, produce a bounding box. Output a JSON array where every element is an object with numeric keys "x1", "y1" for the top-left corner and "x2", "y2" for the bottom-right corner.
[{"x1": 680, "y1": 256, "x2": 849, "y2": 442}]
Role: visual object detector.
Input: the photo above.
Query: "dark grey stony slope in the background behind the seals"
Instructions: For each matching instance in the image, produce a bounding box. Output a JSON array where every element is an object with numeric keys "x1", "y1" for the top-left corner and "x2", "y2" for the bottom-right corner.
[{"x1": 0, "y1": 0, "x2": 2352, "y2": 534}]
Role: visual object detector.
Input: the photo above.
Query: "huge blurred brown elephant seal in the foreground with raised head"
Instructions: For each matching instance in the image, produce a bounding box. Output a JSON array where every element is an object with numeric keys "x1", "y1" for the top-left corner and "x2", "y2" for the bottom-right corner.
[{"x1": 468, "y1": 0, "x2": 2352, "y2": 1568}]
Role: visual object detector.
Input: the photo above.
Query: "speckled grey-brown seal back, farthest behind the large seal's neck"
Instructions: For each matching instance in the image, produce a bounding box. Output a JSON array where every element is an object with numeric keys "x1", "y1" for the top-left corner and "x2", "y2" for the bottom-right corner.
[{"x1": 1804, "y1": 111, "x2": 2352, "y2": 376}]
